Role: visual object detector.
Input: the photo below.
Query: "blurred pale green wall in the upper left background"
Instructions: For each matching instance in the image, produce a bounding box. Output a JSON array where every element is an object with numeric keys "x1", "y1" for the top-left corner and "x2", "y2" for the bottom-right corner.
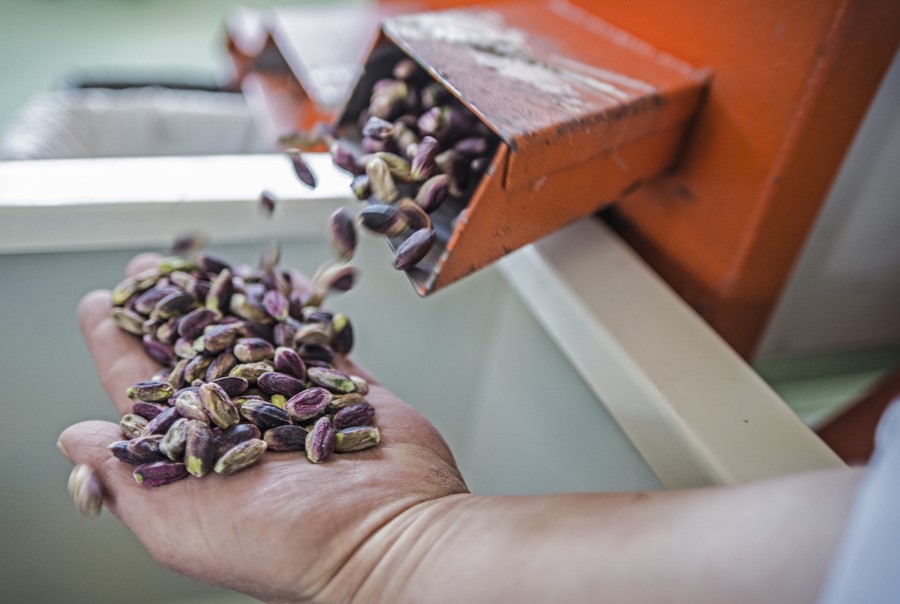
[{"x1": 0, "y1": 0, "x2": 358, "y2": 129}]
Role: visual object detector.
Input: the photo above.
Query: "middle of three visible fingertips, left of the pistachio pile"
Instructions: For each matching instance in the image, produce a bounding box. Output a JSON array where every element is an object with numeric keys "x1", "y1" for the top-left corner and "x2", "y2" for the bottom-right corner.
[{"x1": 78, "y1": 291, "x2": 160, "y2": 413}]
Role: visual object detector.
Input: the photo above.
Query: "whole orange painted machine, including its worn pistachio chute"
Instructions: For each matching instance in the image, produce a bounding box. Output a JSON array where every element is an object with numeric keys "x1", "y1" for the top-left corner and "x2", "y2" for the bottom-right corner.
[{"x1": 227, "y1": 0, "x2": 900, "y2": 356}]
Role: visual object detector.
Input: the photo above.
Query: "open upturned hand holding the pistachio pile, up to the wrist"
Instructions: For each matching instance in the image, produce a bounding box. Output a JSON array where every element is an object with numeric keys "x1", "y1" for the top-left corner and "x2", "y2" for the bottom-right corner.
[{"x1": 59, "y1": 255, "x2": 466, "y2": 602}]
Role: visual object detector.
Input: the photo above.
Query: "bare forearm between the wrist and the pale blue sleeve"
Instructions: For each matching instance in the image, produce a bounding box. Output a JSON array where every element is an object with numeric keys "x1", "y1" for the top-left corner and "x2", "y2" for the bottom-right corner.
[{"x1": 358, "y1": 470, "x2": 859, "y2": 603}]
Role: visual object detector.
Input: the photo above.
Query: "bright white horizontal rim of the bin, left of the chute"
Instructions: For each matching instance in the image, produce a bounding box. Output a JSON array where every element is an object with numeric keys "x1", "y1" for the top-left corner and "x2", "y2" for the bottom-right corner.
[{"x1": 0, "y1": 154, "x2": 351, "y2": 254}]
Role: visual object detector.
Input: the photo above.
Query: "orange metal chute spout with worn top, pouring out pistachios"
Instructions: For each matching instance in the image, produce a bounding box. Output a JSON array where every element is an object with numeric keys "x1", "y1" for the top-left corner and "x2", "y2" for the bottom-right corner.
[{"x1": 339, "y1": 3, "x2": 709, "y2": 295}]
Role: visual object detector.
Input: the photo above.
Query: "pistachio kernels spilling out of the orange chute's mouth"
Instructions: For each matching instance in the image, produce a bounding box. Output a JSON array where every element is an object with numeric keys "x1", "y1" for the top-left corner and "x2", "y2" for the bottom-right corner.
[{"x1": 281, "y1": 58, "x2": 499, "y2": 271}]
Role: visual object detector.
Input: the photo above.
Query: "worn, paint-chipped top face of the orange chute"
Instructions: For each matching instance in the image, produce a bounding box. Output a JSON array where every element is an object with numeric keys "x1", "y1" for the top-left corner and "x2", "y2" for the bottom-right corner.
[{"x1": 384, "y1": 3, "x2": 707, "y2": 185}]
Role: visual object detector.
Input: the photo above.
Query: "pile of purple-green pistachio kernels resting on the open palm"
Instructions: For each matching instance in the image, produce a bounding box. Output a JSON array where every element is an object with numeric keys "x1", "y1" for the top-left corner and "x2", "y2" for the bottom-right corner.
[{"x1": 108, "y1": 246, "x2": 380, "y2": 486}]
